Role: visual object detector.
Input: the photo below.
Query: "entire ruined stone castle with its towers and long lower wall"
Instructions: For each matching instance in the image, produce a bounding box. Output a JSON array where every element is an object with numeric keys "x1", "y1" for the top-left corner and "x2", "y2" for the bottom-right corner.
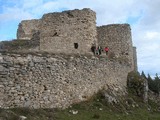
[{"x1": 0, "y1": 8, "x2": 137, "y2": 108}]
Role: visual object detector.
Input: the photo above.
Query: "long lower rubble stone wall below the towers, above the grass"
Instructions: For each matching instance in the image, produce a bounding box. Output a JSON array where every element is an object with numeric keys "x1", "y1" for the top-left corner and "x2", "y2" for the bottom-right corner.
[{"x1": 0, "y1": 53, "x2": 132, "y2": 108}]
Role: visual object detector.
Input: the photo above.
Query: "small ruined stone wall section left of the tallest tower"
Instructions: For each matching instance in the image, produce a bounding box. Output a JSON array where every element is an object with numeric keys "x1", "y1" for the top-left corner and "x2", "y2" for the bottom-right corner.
[{"x1": 17, "y1": 19, "x2": 41, "y2": 40}]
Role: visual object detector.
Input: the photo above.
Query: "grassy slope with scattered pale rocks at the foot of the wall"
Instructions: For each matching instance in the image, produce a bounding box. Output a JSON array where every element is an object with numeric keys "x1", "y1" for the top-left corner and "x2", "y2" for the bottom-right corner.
[{"x1": 0, "y1": 95, "x2": 160, "y2": 120}]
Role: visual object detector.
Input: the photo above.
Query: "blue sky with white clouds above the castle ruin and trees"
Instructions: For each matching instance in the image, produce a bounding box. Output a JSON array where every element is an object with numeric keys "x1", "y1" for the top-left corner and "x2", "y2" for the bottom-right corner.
[{"x1": 0, "y1": 0, "x2": 160, "y2": 76}]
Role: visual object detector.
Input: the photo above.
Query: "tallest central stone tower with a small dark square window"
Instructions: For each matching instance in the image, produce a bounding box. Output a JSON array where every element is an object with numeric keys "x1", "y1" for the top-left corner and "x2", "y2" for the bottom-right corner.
[{"x1": 40, "y1": 9, "x2": 97, "y2": 54}]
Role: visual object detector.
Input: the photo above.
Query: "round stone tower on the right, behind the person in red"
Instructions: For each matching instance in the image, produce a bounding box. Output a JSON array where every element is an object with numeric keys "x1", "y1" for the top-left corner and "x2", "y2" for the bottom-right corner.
[{"x1": 97, "y1": 24, "x2": 134, "y2": 68}]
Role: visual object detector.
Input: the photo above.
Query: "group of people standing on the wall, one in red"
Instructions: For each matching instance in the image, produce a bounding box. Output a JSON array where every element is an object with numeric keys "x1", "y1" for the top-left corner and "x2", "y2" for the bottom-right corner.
[{"x1": 91, "y1": 46, "x2": 109, "y2": 55}]
